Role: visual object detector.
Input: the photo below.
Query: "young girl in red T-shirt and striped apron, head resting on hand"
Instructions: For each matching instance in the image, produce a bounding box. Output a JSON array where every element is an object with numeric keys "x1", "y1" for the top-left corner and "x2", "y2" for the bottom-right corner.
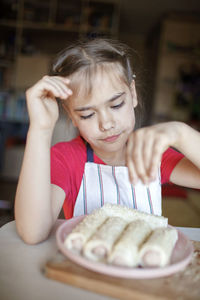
[{"x1": 15, "y1": 39, "x2": 200, "y2": 244}]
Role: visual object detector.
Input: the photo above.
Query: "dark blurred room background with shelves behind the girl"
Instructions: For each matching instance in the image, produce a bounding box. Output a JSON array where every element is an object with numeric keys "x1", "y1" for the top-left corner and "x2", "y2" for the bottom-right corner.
[{"x1": 0, "y1": 0, "x2": 200, "y2": 227}]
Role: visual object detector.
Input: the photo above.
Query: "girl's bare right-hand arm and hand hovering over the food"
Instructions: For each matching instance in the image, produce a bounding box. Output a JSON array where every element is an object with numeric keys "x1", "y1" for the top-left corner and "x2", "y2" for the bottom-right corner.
[{"x1": 127, "y1": 122, "x2": 200, "y2": 188}]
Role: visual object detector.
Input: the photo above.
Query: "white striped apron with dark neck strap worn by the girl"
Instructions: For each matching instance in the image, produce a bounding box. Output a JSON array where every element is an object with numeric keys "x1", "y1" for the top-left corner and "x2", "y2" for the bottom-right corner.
[{"x1": 73, "y1": 144, "x2": 162, "y2": 217}]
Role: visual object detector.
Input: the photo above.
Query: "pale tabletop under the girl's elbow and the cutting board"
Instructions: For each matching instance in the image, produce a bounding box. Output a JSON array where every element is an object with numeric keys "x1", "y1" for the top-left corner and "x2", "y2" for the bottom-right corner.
[{"x1": 0, "y1": 220, "x2": 200, "y2": 300}]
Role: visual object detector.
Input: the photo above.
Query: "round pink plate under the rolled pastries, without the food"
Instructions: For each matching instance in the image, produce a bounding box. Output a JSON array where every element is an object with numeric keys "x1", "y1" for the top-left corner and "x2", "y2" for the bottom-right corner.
[{"x1": 56, "y1": 216, "x2": 193, "y2": 279}]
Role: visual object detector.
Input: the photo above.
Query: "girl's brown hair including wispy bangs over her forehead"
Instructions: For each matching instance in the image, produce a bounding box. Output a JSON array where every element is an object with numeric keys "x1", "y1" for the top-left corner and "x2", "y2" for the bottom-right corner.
[{"x1": 51, "y1": 38, "x2": 143, "y2": 126}]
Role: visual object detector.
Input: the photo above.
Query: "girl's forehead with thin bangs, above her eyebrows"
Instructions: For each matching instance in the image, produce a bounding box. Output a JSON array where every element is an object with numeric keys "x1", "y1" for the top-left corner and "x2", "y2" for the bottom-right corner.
[{"x1": 70, "y1": 63, "x2": 128, "y2": 104}]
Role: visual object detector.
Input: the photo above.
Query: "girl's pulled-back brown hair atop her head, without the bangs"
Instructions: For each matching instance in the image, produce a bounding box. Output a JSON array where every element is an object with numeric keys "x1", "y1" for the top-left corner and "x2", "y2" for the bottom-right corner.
[{"x1": 52, "y1": 38, "x2": 133, "y2": 83}]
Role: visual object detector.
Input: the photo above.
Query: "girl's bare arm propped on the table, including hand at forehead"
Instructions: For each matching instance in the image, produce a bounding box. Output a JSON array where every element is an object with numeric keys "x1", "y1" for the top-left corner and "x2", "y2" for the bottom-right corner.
[{"x1": 15, "y1": 76, "x2": 70, "y2": 244}]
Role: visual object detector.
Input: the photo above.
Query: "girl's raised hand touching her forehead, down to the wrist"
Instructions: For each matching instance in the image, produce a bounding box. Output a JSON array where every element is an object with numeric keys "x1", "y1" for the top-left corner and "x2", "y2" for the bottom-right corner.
[{"x1": 26, "y1": 76, "x2": 72, "y2": 130}]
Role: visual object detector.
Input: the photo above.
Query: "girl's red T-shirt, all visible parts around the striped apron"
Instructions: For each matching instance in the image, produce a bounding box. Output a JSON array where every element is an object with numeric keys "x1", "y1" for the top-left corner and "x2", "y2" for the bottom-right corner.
[{"x1": 51, "y1": 136, "x2": 183, "y2": 219}]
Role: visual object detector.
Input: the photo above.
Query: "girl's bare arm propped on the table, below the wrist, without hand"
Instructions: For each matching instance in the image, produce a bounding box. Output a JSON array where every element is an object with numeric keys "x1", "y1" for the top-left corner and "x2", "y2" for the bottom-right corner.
[{"x1": 15, "y1": 130, "x2": 65, "y2": 244}]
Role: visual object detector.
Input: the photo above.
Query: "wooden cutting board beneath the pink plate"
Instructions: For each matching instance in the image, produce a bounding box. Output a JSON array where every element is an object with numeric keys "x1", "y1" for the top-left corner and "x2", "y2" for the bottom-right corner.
[{"x1": 45, "y1": 242, "x2": 200, "y2": 300}]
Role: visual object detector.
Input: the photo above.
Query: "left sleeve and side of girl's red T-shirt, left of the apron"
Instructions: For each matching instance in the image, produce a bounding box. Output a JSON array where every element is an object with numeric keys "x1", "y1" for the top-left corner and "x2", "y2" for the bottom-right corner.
[{"x1": 51, "y1": 137, "x2": 86, "y2": 219}]
